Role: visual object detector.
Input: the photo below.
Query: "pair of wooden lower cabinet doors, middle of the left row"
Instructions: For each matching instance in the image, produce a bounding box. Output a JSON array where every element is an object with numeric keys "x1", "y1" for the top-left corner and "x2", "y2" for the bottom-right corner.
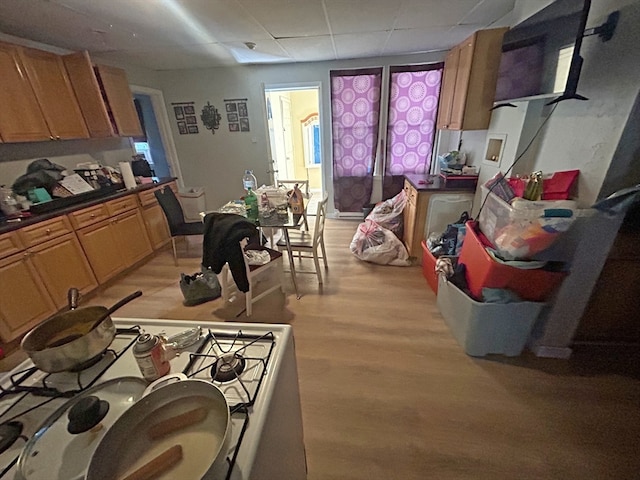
[{"x1": 77, "y1": 209, "x2": 153, "y2": 283}]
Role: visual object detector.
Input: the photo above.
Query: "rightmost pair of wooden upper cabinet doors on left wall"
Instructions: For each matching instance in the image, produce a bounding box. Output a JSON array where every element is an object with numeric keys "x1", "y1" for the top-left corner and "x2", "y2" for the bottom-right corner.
[{"x1": 62, "y1": 52, "x2": 143, "y2": 137}]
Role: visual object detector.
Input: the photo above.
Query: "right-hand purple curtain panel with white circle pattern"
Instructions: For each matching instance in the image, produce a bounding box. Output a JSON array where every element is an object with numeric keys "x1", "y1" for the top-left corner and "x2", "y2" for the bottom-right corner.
[{"x1": 385, "y1": 69, "x2": 442, "y2": 175}]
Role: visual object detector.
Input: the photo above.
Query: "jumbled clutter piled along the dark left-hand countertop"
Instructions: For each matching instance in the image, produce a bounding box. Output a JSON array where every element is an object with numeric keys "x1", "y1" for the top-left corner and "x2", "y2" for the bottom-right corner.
[{"x1": 0, "y1": 155, "x2": 170, "y2": 233}]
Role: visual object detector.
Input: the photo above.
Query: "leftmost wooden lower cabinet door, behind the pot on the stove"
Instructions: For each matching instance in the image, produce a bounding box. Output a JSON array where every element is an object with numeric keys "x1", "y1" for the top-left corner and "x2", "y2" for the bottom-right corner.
[{"x1": 0, "y1": 252, "x2": 57, "y2": 342}]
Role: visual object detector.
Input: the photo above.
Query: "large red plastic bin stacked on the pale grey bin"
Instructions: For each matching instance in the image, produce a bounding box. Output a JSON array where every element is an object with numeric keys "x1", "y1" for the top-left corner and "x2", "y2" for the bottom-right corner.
[{"x1": 458, "y1": 221, "x2": 567, "y2": 302}]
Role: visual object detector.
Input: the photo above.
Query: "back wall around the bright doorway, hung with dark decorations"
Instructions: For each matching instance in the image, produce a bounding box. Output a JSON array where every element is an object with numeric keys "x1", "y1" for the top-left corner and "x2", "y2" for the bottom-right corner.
[{"x1": 144, "y1": 52, "x2": 444, "y2": 211}]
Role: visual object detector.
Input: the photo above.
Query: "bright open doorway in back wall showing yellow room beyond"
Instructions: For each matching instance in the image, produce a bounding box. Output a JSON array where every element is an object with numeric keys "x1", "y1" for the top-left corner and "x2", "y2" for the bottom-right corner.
[{"x1": 264, "y1": 84, "x2": 324, "y2": 198}]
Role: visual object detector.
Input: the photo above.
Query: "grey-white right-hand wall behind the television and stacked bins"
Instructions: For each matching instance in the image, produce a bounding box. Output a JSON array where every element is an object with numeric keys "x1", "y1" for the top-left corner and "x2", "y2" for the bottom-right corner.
[{"x1": 474, "y1": 0, "x2": 640, "y2": 356}]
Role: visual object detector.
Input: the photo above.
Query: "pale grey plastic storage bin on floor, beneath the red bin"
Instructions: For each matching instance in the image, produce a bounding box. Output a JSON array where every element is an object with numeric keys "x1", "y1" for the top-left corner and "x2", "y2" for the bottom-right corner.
[{"x1": 437, "y1": 275, "x2": 544, "y2": 357}]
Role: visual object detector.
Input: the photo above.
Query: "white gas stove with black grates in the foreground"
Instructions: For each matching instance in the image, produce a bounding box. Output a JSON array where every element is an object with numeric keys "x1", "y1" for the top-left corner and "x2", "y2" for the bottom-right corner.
[{"x1": 0, "y1": 318, "x2": 306, "y2": 480}]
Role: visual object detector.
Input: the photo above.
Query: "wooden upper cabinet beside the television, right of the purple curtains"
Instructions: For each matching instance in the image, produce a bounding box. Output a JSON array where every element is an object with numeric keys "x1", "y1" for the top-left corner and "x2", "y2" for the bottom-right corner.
[{"x1": 437, "y1": 28, "x2": 507, "y2": 130}]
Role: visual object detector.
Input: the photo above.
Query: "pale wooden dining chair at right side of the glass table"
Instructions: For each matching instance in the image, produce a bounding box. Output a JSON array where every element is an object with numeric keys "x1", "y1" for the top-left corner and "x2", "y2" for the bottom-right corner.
[{"x1": 278, "y1": 193, "x2": 329, "y2": 284}]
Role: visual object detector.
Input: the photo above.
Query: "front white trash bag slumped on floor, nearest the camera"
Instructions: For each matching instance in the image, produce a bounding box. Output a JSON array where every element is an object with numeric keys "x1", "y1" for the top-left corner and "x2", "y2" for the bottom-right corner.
[{"x1": 349, "y1": 218, "x2": 411, "y2": 267}]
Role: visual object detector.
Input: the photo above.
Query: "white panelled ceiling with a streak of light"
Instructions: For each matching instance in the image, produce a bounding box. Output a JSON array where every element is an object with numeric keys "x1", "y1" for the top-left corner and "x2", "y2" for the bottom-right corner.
[{"x1": 0, "y1": 0, "x2": 515, "y2": 70}]
